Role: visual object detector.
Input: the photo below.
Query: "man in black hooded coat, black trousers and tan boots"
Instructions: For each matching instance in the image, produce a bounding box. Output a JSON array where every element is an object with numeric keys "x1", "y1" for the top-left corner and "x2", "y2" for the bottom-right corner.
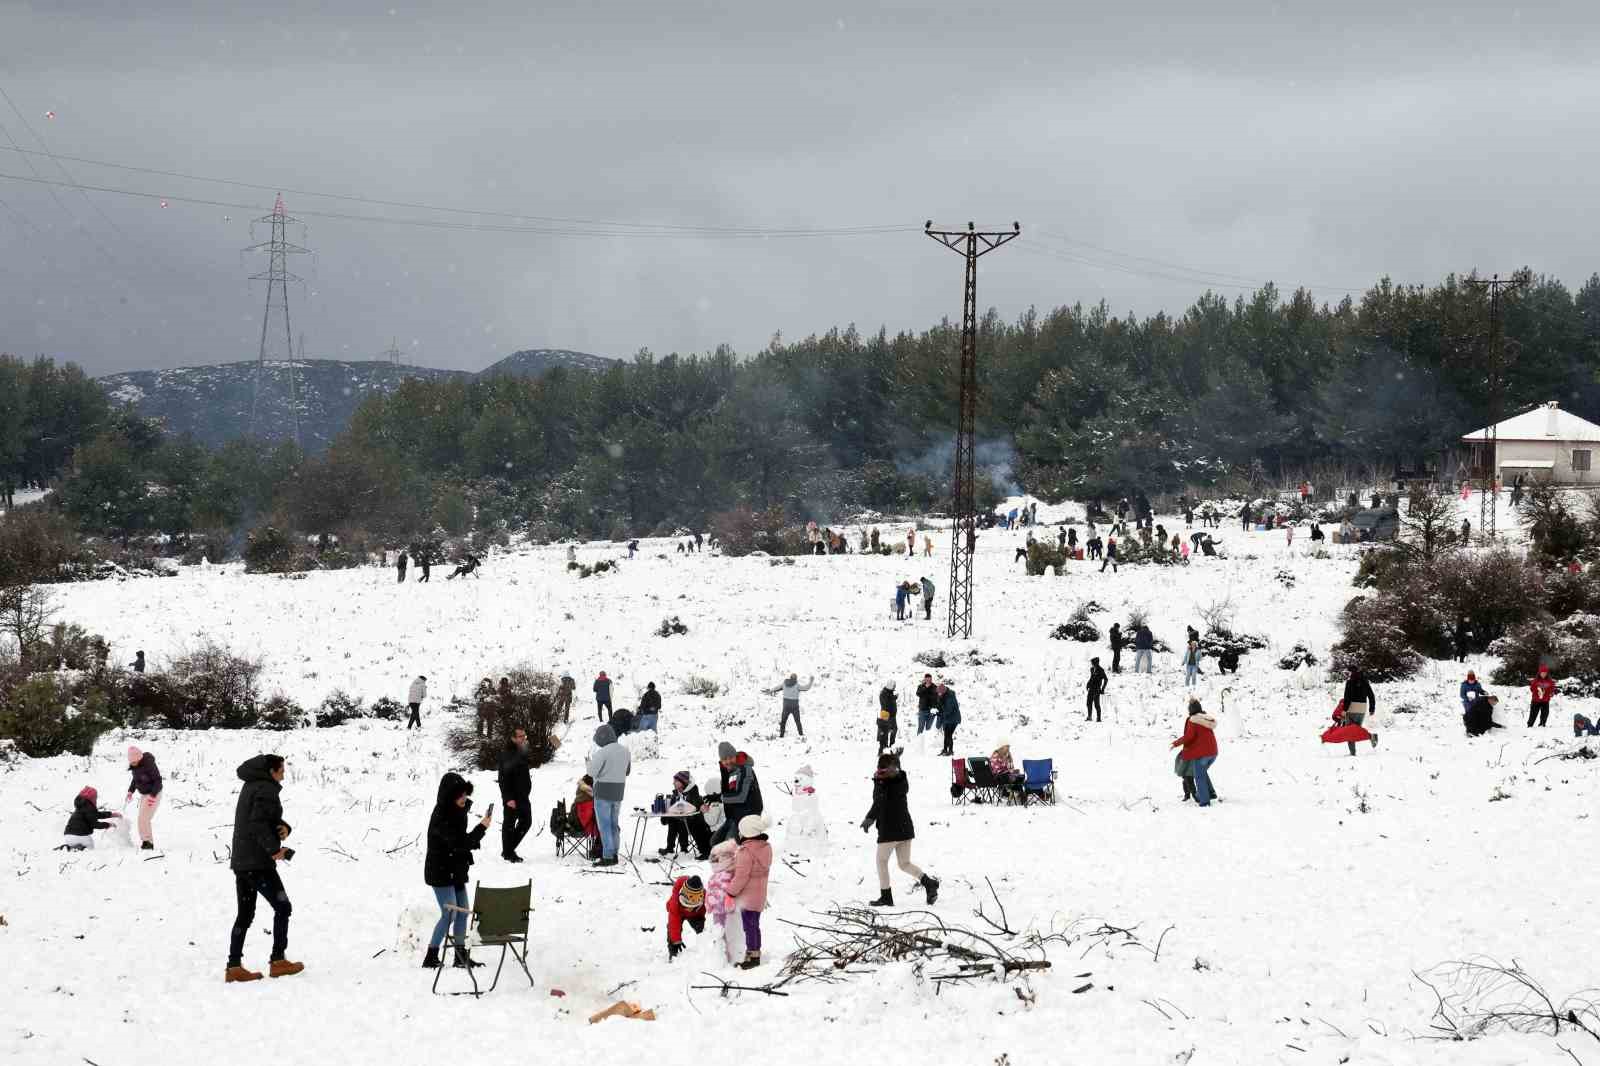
[{"x1": 222, "y1": 755, "x2": 306, "y2": 981}]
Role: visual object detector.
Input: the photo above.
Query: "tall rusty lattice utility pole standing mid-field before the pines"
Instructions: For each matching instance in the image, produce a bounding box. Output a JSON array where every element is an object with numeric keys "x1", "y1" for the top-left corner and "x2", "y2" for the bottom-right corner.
[{"x1": 923, "y1": 221, "x2": 1022, "y2": 637}]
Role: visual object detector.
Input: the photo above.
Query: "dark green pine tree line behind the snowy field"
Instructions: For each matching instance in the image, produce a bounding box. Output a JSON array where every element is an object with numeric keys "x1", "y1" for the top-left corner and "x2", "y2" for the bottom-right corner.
[{"x1": 9, "y1": 271, "x2": 1600, "y2": 544}]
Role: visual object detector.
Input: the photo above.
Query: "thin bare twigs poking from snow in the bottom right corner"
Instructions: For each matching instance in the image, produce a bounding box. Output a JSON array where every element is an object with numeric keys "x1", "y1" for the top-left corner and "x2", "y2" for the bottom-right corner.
[{"x1": 1413, "y1": 956, "x2": 1600, "y2": 1040}]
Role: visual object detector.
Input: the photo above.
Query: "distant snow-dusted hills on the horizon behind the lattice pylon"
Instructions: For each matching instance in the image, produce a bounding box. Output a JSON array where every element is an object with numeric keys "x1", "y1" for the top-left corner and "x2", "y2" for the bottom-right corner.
[{"x1": 99, "y1": 349, "x2": 613, "y2": 453}]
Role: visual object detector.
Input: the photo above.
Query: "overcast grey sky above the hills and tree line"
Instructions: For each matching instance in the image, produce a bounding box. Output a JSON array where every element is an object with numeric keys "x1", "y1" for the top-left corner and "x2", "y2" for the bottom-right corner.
[{"x1": 0, "y1": 0, "x2": 1600, "y2": 373}]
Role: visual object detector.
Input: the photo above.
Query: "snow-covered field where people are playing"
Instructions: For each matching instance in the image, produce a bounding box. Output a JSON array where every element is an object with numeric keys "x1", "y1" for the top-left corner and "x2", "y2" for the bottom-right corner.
[{"x1": 0, "y1": 501, "x2": 1600, "y2": 1066}]
